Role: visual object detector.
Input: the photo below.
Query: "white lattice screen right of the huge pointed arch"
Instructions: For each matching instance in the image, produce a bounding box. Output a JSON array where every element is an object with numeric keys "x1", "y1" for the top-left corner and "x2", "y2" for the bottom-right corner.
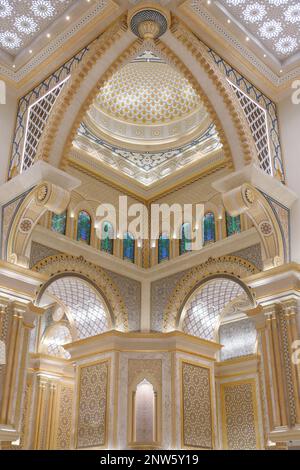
[{"x1": 228, "y1": 80, "x2": 273, "y2": 175}]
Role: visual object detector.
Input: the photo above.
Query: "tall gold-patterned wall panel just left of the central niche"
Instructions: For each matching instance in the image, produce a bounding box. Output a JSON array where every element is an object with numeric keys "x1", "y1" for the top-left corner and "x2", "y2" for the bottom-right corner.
[{"x1": 76, "y1": 361, "x2": 109, "y2": 449}]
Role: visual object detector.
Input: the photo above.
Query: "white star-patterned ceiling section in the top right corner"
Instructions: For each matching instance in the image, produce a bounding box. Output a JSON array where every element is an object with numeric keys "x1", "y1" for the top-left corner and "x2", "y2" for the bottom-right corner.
[{"x1": 214, "y1": 0, "x2": 300, "y2": 60}]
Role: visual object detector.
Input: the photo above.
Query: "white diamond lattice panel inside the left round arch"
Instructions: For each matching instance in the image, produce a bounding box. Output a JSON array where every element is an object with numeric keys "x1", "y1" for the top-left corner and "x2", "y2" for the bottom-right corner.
[{"x1": 47, "y1": 277, "x2": 109, "y2": 339}]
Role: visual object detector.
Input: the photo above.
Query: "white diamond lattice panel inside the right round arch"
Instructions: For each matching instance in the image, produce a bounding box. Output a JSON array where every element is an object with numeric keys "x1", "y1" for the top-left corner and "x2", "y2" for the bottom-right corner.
[{"x1": 182, "y1": 279, "x2": 246, "y2": 340}]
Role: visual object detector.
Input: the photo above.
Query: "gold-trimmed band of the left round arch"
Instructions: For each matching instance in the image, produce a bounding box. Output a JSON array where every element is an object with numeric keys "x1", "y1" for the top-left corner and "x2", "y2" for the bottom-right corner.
[{"x1": 32, "y1": 254, "x2": 128, "y2": 331}]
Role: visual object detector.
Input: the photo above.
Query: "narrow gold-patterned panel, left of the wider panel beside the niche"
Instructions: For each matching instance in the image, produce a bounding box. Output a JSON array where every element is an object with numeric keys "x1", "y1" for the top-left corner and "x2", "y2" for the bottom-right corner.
[{"x1": 56, "y1": 384, "x2": 74, "y2": 450}]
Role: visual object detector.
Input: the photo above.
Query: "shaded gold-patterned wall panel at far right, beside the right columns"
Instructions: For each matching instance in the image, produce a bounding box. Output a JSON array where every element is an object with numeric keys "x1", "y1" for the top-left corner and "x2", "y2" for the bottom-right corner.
[{"x1": 221, "y1": 379, "x2": 259, "y2": 450}]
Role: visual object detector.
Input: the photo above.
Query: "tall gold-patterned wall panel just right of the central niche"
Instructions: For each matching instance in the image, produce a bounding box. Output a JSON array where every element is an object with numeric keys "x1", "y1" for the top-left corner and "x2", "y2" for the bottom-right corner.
[{"x1": 182, "y1": 362, "x2": 213, "y2": 449}]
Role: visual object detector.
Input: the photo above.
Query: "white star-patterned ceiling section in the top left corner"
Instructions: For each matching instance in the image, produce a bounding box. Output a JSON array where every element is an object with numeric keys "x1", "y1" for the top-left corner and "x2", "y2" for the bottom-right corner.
[{"x1": 0, "y1": 0, "x2": 74, "y2": 54}]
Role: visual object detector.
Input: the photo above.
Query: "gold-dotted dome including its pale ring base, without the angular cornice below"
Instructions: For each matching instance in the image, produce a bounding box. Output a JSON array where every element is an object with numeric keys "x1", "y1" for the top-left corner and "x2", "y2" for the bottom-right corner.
[{"x1": 85, "y1": 50, "x2": 210, "y2": 151}]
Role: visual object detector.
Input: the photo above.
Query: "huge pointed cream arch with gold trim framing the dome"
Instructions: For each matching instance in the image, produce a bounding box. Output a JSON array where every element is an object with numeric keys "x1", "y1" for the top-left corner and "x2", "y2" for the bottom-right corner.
[{"x1": 33, "y1": 17, "x2": 257, "y2": 176}]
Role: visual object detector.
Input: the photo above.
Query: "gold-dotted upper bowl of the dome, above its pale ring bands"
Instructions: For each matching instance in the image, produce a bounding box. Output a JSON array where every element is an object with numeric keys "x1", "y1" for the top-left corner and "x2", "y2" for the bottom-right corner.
[{"x1": 97, "y1": 60, "x2": 200, "y2": 125}]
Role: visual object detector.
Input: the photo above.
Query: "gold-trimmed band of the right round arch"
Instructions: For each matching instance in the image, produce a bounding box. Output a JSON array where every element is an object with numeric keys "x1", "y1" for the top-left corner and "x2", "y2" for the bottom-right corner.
[{"x1": 163, "y1": 256, "x2": 259, "y2": 332}]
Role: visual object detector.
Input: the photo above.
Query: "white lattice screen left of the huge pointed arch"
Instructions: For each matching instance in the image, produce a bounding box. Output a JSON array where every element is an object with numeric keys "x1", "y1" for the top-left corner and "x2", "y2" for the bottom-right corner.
[{"x1": 21, "y1": 76, "x2": 70, "y2": 171}]
